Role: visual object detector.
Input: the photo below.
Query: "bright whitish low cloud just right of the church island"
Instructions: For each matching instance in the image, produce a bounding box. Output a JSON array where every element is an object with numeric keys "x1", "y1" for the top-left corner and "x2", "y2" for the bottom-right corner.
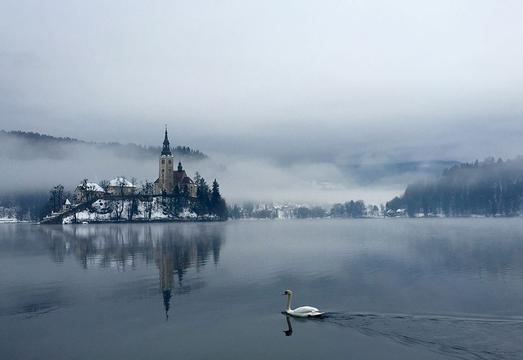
[{"x1": 194, "y1": 155, "x2": 402, "y2": 205}]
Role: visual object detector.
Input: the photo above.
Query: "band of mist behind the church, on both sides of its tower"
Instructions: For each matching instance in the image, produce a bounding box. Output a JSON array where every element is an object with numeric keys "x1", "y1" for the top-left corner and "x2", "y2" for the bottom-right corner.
[{"x1": 0, "y1": 134, "x2": 449, "y2": 205}]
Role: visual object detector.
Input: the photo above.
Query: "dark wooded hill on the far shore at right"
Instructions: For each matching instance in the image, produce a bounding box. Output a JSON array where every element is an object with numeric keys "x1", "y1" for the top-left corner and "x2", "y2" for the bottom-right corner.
[{"x1": 387, "y1": 157, "x2": 523, "y2": 216}]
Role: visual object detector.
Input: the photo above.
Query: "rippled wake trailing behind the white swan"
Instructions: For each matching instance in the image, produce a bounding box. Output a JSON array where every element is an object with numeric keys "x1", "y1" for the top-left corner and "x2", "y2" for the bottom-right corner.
[{"x1": 321, "y1": 313, "x2": 523, "y2": 360}]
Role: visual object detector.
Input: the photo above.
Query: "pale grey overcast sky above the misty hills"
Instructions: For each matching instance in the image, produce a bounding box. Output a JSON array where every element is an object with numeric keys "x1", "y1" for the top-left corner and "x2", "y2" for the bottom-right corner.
[{"x1": 0, "y1": 0, "x2": 523, "y2": 186}]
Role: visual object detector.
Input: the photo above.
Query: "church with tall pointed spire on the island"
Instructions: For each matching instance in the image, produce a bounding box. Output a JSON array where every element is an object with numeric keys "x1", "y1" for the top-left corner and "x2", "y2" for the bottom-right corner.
[{"x1": 154, "y1": 129, "x2": 197, "y2": 198}]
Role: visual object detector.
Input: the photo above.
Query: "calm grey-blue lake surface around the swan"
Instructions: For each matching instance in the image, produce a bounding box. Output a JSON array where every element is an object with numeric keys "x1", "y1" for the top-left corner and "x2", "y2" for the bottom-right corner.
[{"x1": 0, "y1": 219, "x2": 523, "y2": 360}]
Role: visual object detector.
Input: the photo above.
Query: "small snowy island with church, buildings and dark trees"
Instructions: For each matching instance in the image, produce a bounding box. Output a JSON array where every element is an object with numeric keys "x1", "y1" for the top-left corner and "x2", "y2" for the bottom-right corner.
[{"x1": 40, "y1": 127, "x2": 227, "y2": 224}]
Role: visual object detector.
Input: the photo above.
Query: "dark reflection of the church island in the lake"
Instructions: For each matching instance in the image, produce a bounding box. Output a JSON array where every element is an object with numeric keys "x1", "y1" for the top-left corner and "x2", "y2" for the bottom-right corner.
[{"x1": 42, "y1": 223, "x2": 224, "y2": 319}]
